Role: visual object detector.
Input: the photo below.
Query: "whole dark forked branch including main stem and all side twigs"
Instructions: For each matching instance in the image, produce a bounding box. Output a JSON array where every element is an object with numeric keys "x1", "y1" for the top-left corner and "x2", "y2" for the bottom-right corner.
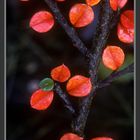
[{"x1": 45, "y1": 0, "x2": 134, "y2": 137}]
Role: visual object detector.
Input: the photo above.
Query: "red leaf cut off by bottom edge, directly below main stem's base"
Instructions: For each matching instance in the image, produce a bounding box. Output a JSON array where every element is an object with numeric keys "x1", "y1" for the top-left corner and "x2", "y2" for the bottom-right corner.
[{"x1": 60, "y1": 133, "x2": 83, "y2": 140}]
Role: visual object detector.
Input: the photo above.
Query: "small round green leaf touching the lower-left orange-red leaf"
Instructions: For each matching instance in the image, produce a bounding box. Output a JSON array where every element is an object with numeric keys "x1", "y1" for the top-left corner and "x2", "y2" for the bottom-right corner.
[{"x1": 39, "y1": 78, "x2": 54, "y2": 91}]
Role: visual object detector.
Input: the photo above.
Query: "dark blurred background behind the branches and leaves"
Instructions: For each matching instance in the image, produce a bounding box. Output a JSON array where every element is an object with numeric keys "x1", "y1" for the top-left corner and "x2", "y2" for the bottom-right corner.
[{"x1": 7, "y1": 0, "x2": 134, "y2": 140}]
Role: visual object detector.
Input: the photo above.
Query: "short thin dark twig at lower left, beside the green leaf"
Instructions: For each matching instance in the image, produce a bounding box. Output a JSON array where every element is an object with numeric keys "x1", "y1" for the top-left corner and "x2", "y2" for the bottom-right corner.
[{"x1": 54, "y1": 83, "x2": 75, "y2": 114}]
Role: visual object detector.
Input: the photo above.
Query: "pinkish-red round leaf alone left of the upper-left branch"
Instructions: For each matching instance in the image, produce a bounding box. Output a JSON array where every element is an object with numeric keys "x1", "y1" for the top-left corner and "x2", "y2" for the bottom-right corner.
[{"x1": 30, "y1": 11, "x2": 54, "y2": 33}]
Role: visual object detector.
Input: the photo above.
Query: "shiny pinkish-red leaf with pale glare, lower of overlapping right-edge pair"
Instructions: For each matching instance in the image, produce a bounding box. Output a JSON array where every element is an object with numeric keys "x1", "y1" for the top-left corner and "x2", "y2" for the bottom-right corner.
[{"x1": 117, "y1": 23, "x2": 134, "y2": 43}]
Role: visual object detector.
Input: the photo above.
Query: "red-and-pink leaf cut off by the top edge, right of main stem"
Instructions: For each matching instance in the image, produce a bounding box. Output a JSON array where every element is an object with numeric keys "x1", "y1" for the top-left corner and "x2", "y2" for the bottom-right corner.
[{"x1": 110, "y1": 0, "x2": 127, "y2": 11}]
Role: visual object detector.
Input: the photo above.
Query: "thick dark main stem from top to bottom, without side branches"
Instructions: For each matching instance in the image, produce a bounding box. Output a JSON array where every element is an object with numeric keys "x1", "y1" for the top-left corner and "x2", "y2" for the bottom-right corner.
[{"x1": 72, "y1": 0, "x2": 113, "y2": 136}]
